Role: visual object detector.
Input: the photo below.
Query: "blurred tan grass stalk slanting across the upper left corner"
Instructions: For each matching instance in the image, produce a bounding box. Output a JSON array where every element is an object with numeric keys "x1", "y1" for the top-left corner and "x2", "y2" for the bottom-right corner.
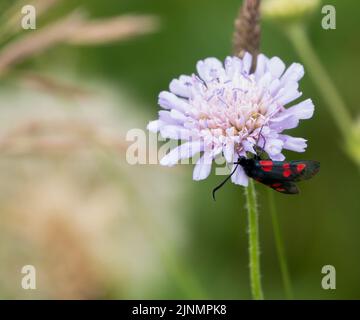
[{"x1": 0, "y1": 11, "x2": 158, "y2": 77}]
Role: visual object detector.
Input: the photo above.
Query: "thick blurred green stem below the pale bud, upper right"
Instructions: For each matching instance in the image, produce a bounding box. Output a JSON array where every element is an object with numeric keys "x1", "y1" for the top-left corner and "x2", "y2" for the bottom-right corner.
[{"x1": 287, "y1": 23, "x2": 352, "y2": 139}]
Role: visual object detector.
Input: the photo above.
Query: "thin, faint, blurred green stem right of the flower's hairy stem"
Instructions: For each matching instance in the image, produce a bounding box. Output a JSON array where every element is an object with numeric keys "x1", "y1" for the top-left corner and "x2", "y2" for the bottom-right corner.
[{"x1": 268, "y1": 189, "x2": 293, "y2": 299}]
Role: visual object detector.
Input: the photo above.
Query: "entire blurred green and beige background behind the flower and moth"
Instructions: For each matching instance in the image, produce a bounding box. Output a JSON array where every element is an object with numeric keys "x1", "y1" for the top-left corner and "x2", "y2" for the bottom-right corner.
[{"x1": 0, "y1": 0, "x2": 360, "y2": 299}]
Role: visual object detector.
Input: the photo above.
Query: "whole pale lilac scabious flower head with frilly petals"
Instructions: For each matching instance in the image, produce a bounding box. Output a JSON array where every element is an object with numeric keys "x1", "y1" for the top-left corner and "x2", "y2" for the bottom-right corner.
[{"x1": 148, "y1": 53, "x2": 314, "y2": 186}]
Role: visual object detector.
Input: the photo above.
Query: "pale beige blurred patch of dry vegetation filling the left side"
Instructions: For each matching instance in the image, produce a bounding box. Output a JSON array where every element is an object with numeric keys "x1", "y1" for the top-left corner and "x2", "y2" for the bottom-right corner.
[{"x1": 0, "y1": 79, "x2": 187, "y2": 299}]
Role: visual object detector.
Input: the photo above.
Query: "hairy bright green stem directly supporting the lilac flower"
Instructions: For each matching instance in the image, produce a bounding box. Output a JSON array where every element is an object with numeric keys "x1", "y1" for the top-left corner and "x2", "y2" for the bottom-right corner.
[{"x1": 245, "y1": 179, "x2": 264, "y2": 300}]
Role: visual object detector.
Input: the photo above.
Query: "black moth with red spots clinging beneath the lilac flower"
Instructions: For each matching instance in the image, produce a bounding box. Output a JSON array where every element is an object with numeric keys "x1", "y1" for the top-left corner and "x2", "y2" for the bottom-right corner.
[{"x1": 212, "y1": 127, "x2": 320, "y2": 200}]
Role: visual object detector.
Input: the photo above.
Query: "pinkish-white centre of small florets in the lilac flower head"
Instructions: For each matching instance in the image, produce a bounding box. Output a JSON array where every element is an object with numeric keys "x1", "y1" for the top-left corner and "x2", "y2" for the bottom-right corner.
[{"x1": 189, "y1": 75, "x2": 270, "y2": 143}]
